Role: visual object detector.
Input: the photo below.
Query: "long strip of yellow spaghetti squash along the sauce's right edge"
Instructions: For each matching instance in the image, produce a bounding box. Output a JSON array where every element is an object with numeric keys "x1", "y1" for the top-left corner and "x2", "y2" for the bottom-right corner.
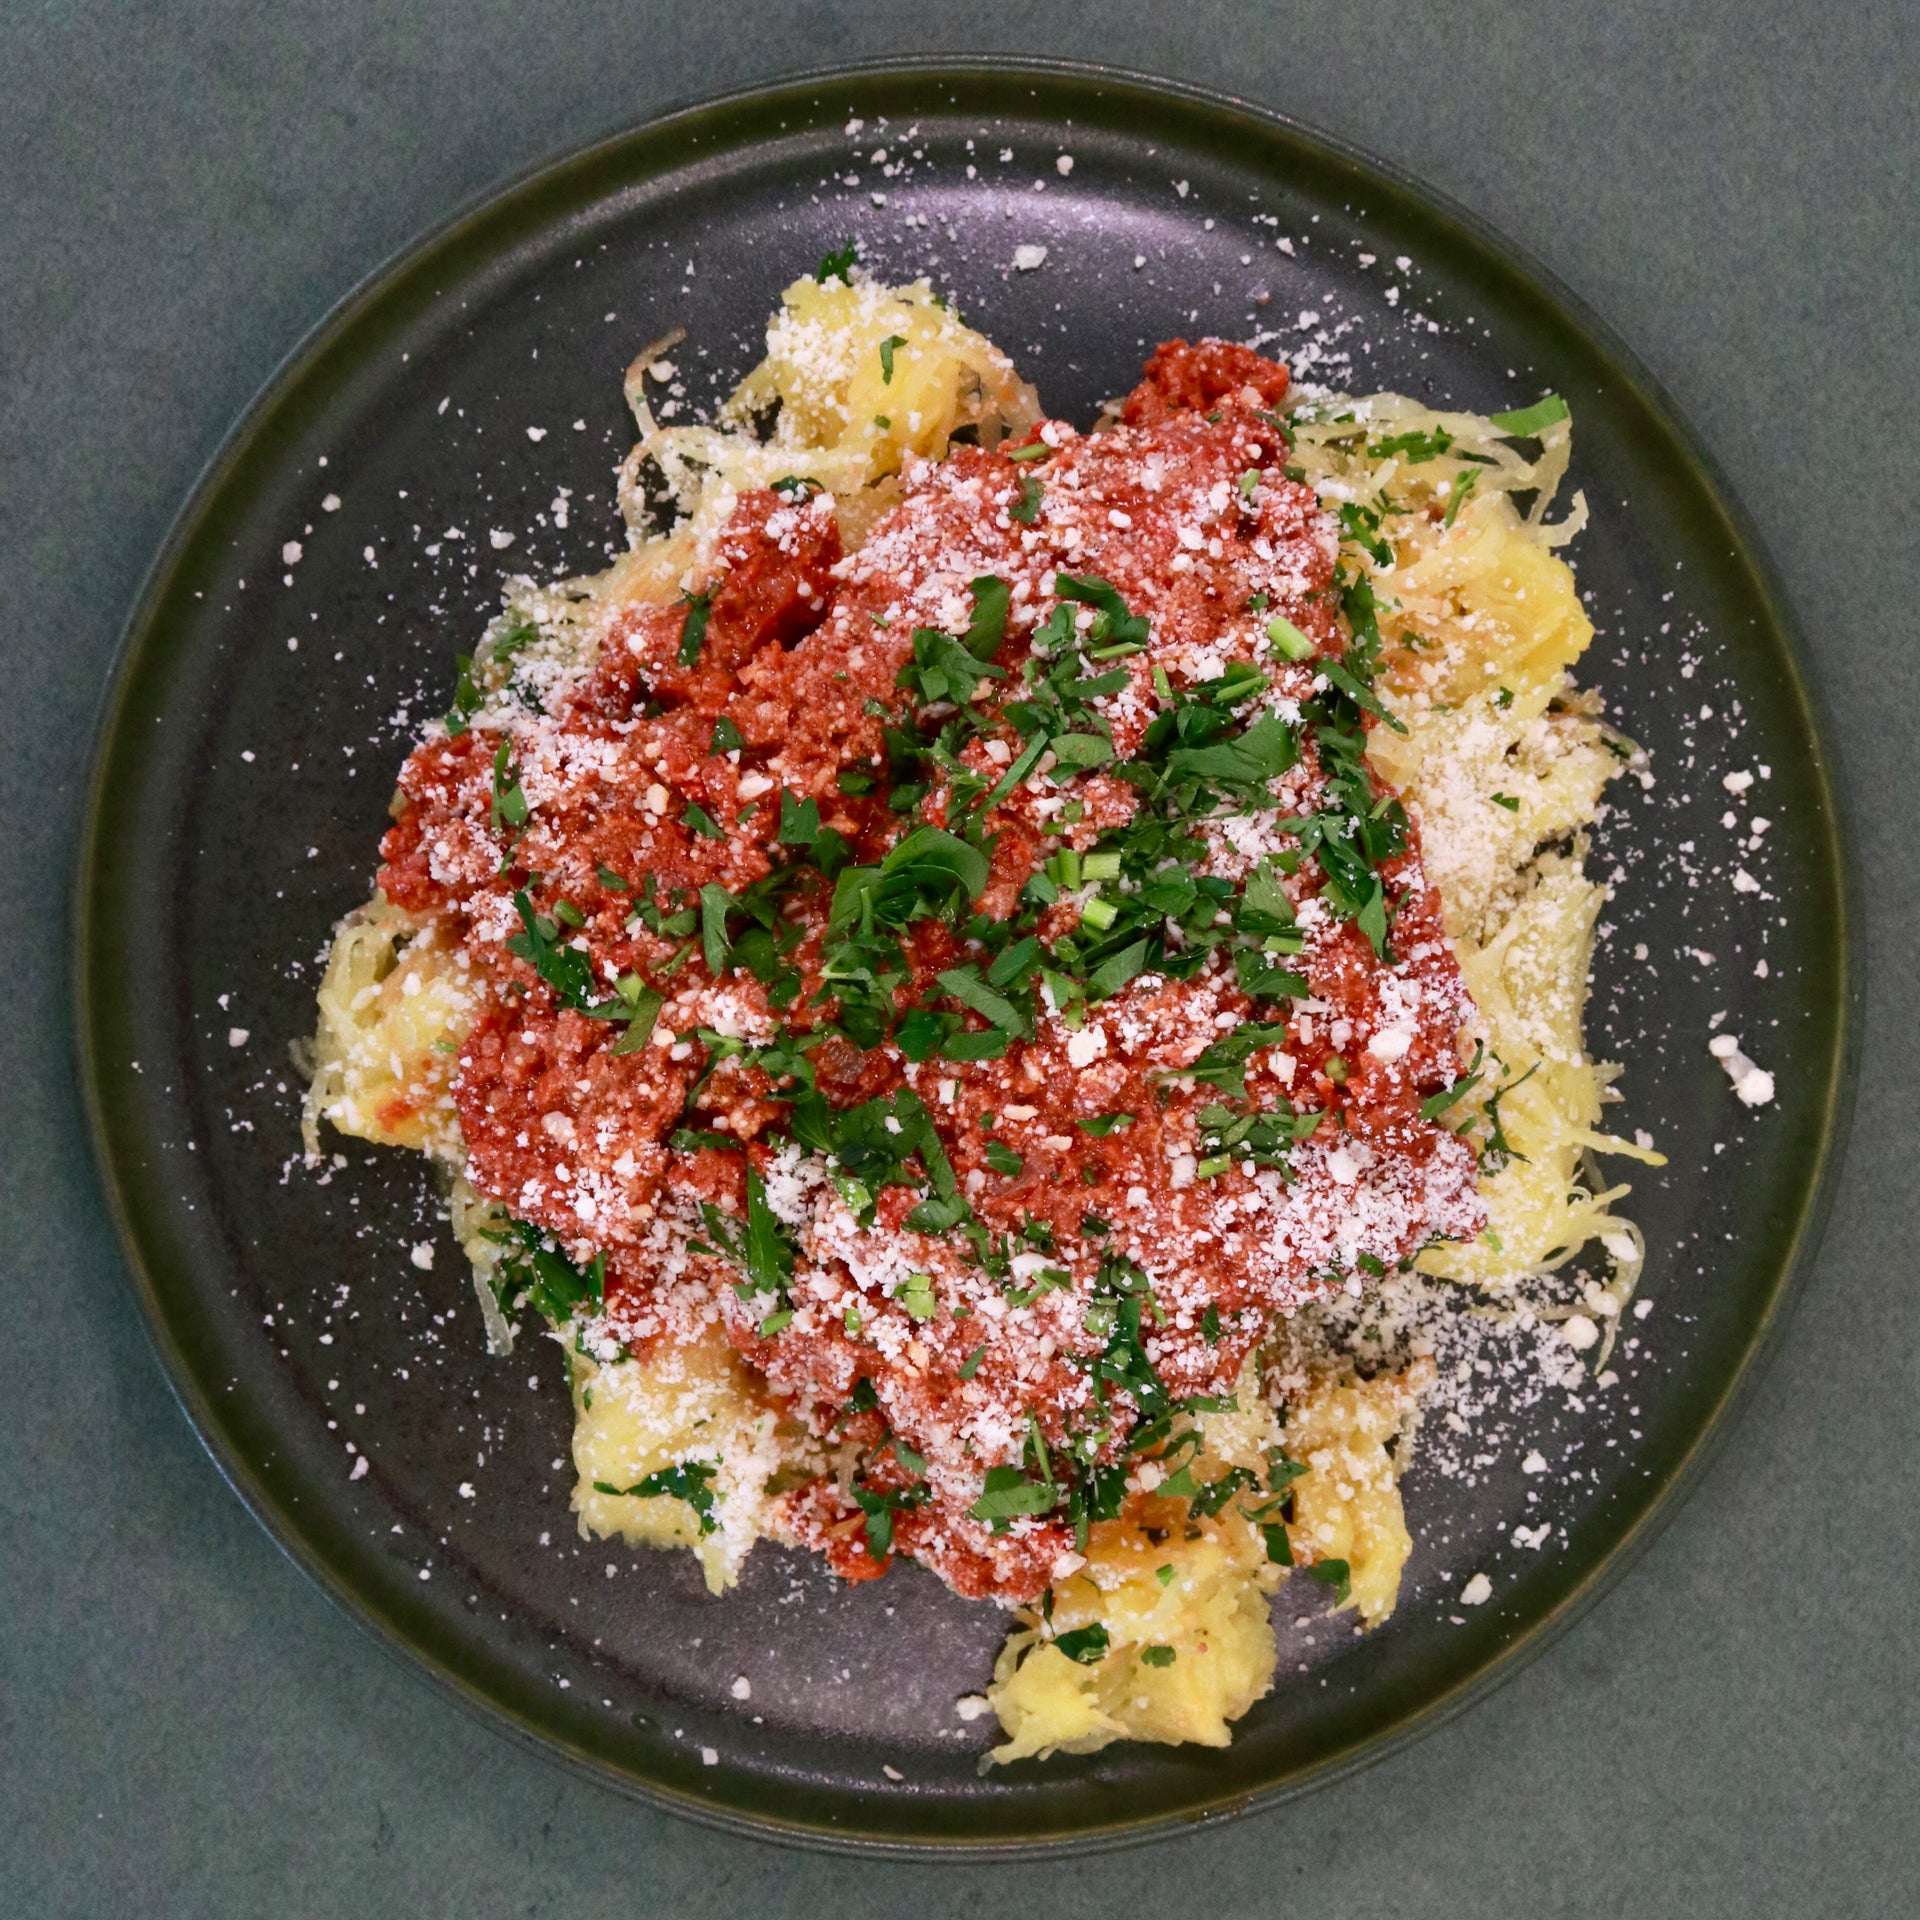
[{"x1": 1294, "y1": 394, "x2": 1663, "y2": 1319}]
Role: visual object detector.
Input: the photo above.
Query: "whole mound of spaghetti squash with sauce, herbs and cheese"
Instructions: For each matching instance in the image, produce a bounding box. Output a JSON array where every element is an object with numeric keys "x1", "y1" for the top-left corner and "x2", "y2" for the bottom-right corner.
[{"x1": 307, "y1": 261, "x2": 1638, "y2": 1759}]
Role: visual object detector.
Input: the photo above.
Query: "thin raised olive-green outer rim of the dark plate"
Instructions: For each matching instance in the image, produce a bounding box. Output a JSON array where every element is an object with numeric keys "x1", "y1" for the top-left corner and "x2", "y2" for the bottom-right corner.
[{"x1": 65, "y1": 52, "x2": 1864, "y2": 1859}]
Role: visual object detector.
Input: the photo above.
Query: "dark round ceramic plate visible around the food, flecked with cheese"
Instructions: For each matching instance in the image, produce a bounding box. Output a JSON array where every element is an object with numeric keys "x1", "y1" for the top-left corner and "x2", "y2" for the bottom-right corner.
[{"x1": 77, "y1": 63, "x2": 1851, "y2": 1849}]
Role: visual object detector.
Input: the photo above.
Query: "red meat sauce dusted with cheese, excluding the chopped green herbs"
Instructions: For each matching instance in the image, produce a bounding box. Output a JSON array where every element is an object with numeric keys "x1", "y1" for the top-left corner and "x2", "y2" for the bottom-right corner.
[{"x1": 380, "y1": 342, "x2": 1482, "y2": 1601}]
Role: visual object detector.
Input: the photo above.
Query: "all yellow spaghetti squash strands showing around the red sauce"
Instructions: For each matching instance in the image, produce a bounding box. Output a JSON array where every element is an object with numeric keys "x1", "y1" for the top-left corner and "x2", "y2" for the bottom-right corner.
[{"x1": 305, "y1": 271, "x2": 1657, "y2": 1763}]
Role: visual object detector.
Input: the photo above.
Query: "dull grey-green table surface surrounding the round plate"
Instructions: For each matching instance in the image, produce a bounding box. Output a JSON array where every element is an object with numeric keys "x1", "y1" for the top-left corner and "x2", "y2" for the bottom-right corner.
[{"x1": 0, "y1": 0, "x2": 1920, "y2": 1920}]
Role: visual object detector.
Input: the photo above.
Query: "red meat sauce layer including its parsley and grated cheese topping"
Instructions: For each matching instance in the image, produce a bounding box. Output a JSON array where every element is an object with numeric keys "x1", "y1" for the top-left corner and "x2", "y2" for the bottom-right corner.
[{"x1": 380, "y1": 340, "x2": 1484, "y2": 1601}]
